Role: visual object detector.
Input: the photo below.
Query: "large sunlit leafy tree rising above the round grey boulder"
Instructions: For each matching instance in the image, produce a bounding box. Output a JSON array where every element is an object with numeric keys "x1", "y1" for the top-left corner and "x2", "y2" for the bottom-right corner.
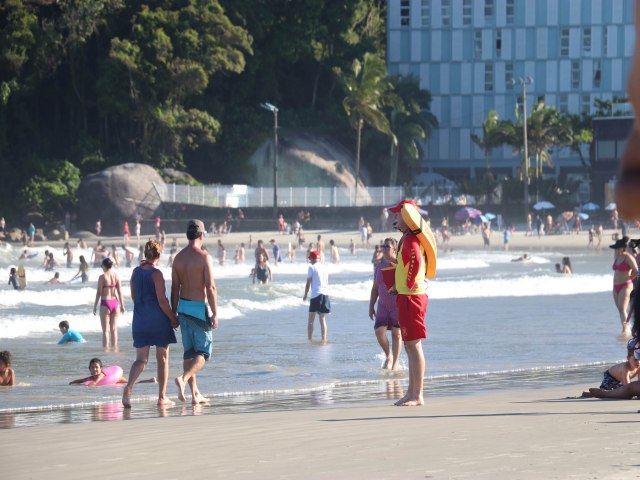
[{"x1": 99, "y1": 0, "x2": 251, "y2": 167}]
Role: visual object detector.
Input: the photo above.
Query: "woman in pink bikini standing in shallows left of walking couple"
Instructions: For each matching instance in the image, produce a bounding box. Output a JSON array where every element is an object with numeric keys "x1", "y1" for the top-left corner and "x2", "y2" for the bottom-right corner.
[{"x1": 93, "y1": 258, "x2": 124, "y2": 349}]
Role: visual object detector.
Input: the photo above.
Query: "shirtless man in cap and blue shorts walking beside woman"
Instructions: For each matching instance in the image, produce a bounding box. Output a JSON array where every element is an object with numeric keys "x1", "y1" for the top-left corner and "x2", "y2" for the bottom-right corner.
[{"x1": 171, "y1": 220, "x2": 218, "y2": 405}]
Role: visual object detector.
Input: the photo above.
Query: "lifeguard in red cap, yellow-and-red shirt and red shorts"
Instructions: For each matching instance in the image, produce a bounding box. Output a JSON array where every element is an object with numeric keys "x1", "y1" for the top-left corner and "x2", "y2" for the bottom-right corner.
[{"x1": 389, "y1": 200, "x2": 429, "y2": 406}]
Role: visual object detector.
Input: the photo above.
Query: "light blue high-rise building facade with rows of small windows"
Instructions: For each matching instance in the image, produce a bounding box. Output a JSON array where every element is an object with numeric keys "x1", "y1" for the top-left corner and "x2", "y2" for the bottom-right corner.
[{"x1": 387, "y1": 0, "x2": 635, "y2": 182}]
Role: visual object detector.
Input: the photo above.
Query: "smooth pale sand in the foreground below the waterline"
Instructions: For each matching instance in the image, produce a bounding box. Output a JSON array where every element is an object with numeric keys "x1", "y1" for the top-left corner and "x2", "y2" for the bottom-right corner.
[{"x1": 0, "y1": 385, "x2": 640, "y2": 479}]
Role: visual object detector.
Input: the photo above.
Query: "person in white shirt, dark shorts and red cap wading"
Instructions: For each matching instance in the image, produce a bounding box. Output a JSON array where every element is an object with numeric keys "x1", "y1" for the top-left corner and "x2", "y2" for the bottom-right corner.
[{"x1": 302, "y1": 250, "x2": 331, "y2": 342}]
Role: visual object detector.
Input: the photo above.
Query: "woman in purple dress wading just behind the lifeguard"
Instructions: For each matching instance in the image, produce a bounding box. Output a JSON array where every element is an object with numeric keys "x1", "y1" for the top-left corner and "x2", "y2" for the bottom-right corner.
[{"x1": 369, "y1": 238, "x2": 401, "y2": 370}]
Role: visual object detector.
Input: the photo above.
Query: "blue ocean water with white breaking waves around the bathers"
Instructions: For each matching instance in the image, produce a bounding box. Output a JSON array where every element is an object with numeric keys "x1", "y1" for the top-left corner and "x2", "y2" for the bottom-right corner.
[{"x1": 0, "y1": 240, "x2": 626, "y2": 428}]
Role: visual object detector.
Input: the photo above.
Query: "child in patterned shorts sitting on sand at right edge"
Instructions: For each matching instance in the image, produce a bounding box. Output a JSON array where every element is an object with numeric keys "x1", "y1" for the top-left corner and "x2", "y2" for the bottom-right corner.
[{"x1": 582, "y1": 338, "x2": 640, "y2": 399}]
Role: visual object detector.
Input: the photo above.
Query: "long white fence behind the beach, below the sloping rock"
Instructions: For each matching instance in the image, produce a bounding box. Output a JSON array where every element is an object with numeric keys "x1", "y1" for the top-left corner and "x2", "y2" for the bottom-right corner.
[{"x1": 155, "y1": 183, "x2": 444, "y2": 208}]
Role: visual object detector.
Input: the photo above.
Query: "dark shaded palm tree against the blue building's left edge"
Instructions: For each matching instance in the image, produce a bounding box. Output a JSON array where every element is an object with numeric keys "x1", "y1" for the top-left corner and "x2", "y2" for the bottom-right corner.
[{"x1": 387, "y1": 76, "x2": 438, "y2": 186}]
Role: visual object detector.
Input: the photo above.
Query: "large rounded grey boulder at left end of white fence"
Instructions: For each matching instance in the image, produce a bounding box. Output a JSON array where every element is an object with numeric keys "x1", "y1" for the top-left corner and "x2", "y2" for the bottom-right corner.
[{"x1": 78, "y1": 163, "x2": 165, "y2": 232}]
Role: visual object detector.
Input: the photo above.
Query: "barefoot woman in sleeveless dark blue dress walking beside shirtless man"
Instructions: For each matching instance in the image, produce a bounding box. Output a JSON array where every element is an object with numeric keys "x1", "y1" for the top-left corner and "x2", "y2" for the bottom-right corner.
[{"x1": 122, "y1": 240, "x2": 179, "y2": 408}]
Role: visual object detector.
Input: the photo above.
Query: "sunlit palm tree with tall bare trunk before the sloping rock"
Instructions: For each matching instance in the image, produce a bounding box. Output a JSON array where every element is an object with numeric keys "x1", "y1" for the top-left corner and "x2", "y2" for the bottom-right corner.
[{"x1": 335, "y1": 53, "x2": 395, "y2": 205}]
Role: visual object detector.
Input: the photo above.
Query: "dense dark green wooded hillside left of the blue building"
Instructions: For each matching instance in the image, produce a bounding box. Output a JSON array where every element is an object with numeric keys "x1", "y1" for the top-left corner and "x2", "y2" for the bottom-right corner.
[{"x1": 0, "y1": 0, "x2": 437, "y2": 217}]
